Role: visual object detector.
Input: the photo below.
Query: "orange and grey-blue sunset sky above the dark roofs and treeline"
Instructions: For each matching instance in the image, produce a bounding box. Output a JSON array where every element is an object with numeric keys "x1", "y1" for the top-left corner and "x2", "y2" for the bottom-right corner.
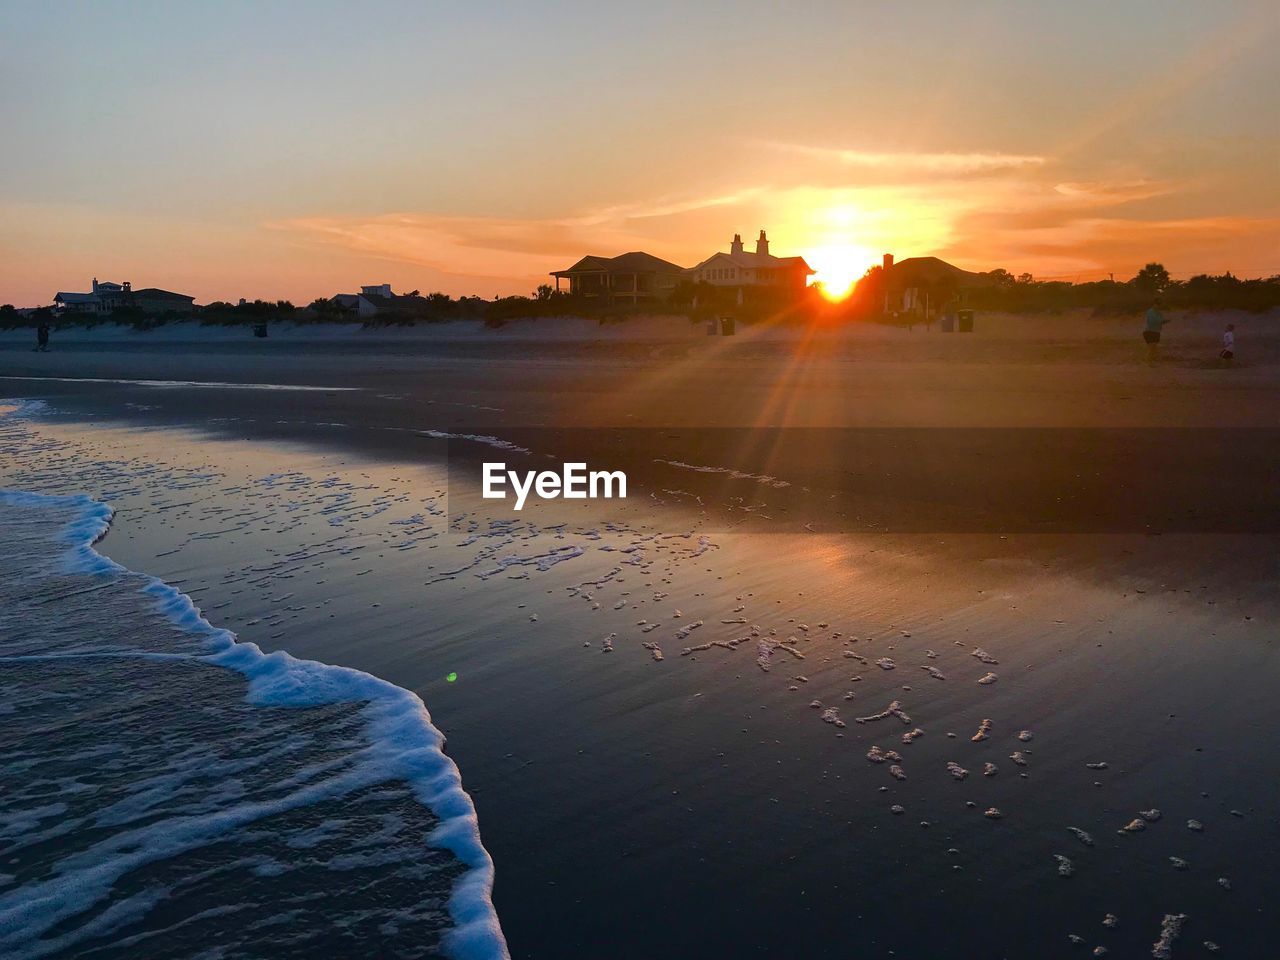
[{"x1": 0, "y1": 0, "x2": 1280, "y2": 306}]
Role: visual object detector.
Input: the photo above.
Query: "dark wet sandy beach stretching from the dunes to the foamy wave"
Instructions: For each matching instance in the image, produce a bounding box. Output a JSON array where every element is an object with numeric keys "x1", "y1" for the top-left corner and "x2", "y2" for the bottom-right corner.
[{"x1": 0, "y1": 317, "x2": 1280, "y2": 957}]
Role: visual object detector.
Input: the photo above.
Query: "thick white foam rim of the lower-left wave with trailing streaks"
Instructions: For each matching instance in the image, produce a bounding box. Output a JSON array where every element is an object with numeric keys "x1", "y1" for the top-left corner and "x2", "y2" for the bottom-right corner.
[{"x1": 0, "y1": 490, "x2": 508, "y2": 960}]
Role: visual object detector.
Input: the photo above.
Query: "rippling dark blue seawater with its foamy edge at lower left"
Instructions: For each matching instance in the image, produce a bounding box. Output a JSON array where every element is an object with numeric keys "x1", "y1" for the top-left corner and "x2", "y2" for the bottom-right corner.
[{"x1": 0, "y1": 419, "x2": 507, "y2": 960}]
